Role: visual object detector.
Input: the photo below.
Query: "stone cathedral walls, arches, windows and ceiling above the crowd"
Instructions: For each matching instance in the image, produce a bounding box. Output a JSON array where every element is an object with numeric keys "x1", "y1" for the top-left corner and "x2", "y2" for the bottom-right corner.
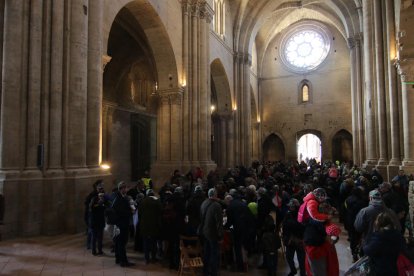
[{"x1": 0, "y1": 0, "x2": 414, "y2": 242}]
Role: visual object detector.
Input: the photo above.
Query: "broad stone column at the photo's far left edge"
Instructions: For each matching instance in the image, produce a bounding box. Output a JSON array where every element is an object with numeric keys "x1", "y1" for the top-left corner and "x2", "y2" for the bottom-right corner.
[{"x1": 0, "y1": 1, "x2": 25, "y2": 170}]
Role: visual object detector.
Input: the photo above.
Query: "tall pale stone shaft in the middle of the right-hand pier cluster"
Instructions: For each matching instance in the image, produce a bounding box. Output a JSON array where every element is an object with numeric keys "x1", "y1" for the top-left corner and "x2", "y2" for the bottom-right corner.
[{"x1": 374, "y1": 1, "x2": 388, "y2": 167}]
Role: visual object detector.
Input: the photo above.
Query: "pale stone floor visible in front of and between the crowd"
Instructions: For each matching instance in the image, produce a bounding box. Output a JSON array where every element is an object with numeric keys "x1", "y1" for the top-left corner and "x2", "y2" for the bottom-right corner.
[{"x1": 0, "y1": 234, "x2": 352, "y2": 276}]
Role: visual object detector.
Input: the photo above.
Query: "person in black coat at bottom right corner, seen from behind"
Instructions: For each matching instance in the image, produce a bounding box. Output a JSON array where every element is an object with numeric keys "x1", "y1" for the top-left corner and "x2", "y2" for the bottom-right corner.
[{"x1": 363, "y1": 211, "x2": 405, "y2": 276}]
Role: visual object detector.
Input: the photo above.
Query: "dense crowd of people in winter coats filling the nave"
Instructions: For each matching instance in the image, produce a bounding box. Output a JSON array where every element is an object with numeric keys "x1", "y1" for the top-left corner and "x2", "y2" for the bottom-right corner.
[{"x1": 85, "y1": 159, "x2": 413, "y2": 276}]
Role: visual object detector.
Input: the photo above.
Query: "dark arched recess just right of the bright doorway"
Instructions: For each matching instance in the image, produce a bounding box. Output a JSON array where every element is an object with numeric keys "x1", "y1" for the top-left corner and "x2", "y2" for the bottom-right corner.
[{"x1": 332, "y1": 129, "x2": 353, "y2": 162}]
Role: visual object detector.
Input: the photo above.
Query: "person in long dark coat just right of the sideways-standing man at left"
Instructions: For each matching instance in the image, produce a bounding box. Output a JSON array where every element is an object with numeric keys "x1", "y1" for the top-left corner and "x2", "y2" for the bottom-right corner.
[{"x1": 138, "y1": 189, "x2": 162, "y2": 264}]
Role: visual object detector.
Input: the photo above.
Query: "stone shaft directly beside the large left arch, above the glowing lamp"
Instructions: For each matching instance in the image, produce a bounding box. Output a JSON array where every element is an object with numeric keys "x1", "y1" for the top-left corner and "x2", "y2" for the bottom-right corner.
[{"x1": 86, "y1": 0, "x2": 104, "y2": 168}]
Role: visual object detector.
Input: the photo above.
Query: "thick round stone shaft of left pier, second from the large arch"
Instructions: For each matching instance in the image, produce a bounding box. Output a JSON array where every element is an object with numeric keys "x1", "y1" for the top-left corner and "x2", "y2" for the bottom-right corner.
[{"x1": 66, "y1": 0, "x2": 88, "y2": 169}]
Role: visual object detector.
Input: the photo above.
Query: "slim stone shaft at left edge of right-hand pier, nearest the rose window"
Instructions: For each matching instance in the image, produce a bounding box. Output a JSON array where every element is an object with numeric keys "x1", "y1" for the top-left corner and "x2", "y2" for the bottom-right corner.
[{"x1": 348, "y1": 35, "x2": 364, "y2": 165}]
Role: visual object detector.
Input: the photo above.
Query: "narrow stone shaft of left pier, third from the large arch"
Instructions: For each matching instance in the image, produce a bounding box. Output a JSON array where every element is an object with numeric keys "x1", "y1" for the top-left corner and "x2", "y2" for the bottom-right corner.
[{"x1": 48, "y1": 1, "x2": 64, "y2": 170}]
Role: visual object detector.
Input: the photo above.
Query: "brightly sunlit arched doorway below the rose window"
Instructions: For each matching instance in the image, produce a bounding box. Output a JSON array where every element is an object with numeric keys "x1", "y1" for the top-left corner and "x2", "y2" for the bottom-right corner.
[{"x1": 297, "y1": 133, "x2": 322, "y2": 163}]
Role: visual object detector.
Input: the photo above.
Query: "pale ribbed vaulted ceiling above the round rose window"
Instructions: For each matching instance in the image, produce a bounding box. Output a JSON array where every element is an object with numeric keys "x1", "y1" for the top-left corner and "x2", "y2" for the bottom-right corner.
[{"x1": 228, "y1": 0, "x2": 362, "y2": 59}]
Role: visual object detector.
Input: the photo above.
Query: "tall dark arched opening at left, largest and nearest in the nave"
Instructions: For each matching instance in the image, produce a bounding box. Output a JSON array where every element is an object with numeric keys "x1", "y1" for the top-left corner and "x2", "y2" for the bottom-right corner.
[{"x1": 102, "y1": 5, "x2": 163, "y2": 181}]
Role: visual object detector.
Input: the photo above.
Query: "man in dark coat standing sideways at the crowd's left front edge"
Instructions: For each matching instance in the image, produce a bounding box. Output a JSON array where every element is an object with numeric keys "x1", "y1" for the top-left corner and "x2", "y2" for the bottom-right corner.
[{"x1": 113, "y1": 181, "x2": 134, "y2": 267}]
